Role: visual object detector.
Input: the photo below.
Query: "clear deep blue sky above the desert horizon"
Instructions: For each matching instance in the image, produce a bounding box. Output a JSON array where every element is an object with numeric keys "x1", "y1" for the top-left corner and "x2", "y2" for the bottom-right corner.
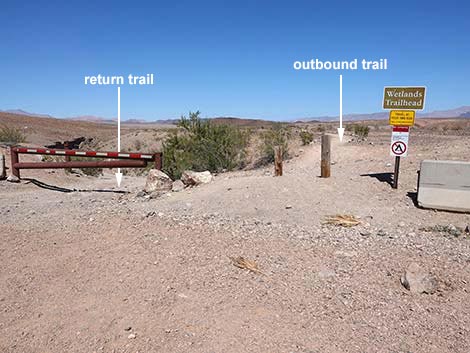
[{"x1": 0, "y1": 0, "x2": 470, "y2": 120}]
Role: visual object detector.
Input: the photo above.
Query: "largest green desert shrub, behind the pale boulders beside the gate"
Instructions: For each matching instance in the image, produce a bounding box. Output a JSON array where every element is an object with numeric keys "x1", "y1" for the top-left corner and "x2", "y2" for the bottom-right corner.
[{"x1": 163, "y1": 111, "x2": 248, "y2": 179}]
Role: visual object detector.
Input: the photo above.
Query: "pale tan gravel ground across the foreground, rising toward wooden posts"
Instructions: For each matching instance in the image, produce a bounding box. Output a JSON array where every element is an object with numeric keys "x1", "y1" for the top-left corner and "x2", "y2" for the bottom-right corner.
[{"x1": 0, "y1": 133, "x2": 470, "y2": 353}]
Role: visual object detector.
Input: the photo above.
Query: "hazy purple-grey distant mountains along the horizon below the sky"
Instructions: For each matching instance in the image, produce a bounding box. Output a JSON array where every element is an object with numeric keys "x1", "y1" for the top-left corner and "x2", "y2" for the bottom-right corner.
[{"x1": 0, "y1": 105, "x2": 470, "y2": 124}]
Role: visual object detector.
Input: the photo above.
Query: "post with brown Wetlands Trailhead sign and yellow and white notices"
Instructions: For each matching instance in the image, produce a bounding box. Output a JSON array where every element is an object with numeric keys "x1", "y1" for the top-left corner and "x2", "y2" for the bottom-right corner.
[{"x1": 382, "y1": 87, "x2": 426, "y2": 189}]
